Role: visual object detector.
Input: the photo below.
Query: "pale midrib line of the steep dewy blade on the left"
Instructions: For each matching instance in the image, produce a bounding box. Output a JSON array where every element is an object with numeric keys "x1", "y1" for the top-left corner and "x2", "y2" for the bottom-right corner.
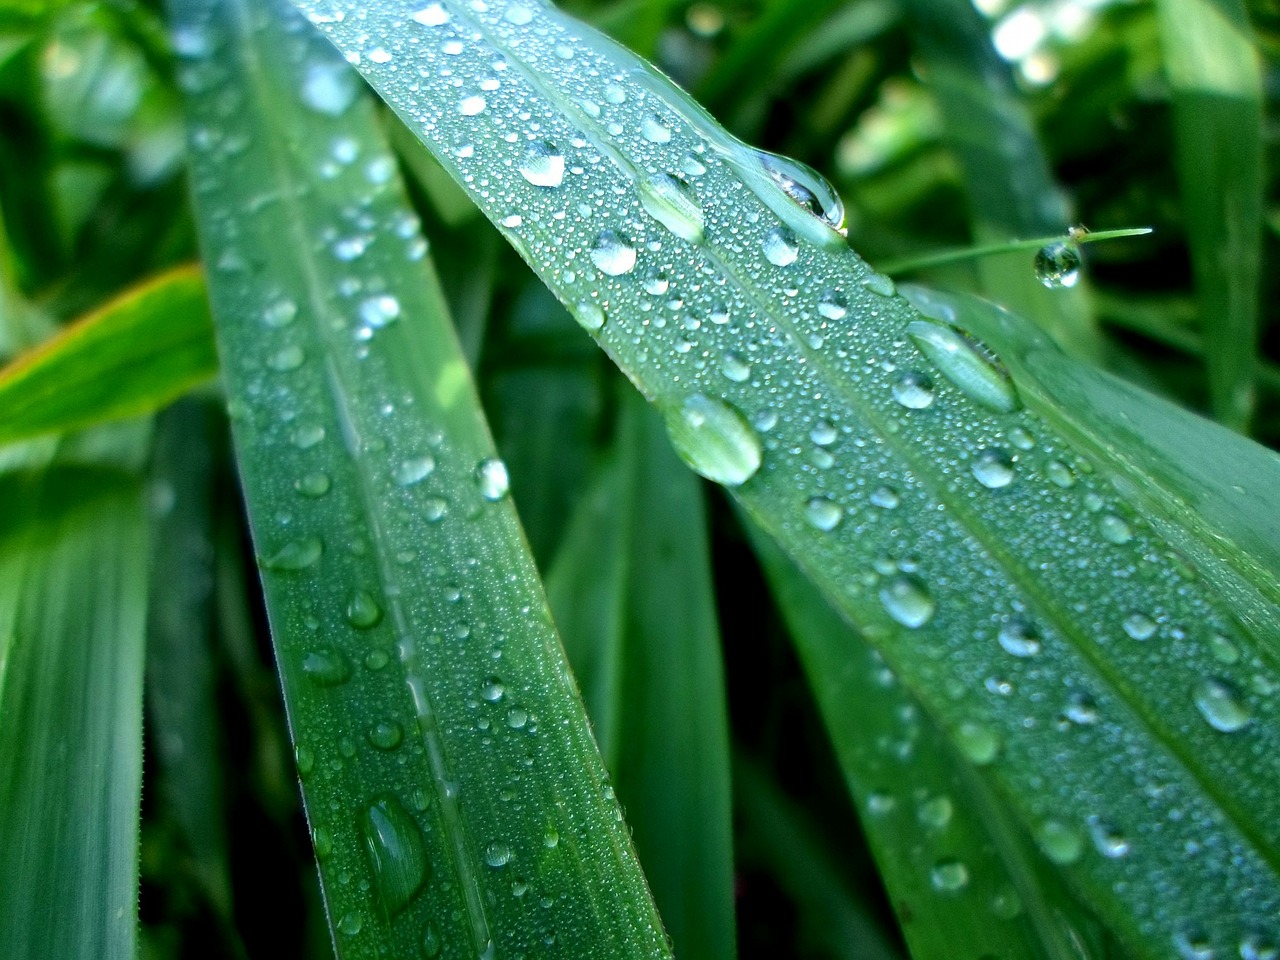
[{"x1": 228, "y1": 0, "x2": 492, "y2": 956}]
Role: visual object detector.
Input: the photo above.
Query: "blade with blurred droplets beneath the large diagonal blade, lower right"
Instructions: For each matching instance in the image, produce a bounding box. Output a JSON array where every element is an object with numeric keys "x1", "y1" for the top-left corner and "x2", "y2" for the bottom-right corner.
[{"x1": 750, "y1": 525, "x2": 1097, "y2": 960}]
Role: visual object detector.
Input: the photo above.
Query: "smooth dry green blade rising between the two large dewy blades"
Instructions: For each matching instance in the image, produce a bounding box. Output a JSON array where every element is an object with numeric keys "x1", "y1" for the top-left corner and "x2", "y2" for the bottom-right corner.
[{"x1": 547, "y1": 392, "x2": 735, "y2": 960}]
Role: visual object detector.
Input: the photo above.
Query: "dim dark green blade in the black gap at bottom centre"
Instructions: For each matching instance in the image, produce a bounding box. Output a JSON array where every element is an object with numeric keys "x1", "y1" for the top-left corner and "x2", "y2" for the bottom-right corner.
[{"x1": 733, "y1": 756, "x2": 901, "y2": 960}]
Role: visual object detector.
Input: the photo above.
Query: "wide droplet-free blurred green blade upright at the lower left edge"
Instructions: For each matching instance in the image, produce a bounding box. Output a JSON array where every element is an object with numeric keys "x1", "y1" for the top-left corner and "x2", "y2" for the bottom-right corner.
[{"x1": 0, "y1": 455, "x2": 147, "y2": 960}]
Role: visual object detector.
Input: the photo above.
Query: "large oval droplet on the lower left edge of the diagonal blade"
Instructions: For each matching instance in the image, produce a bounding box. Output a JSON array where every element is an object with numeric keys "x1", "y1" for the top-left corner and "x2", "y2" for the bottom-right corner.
[{"x1": 664, "y1": 393, "x2": 762, "y2": 486}]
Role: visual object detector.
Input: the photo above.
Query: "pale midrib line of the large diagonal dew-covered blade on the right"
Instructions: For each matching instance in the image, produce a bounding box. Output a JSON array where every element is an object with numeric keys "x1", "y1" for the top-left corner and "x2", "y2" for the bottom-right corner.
[{"x1": 443, "y1": 0, "x2": 1280, "y2": 876}]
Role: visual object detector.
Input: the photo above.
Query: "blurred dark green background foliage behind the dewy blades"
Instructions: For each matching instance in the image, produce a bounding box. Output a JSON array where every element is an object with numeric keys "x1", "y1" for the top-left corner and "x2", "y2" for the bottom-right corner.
[{"x1": 0, "y1": 0, "x2": 1280, "y2": 959}]
